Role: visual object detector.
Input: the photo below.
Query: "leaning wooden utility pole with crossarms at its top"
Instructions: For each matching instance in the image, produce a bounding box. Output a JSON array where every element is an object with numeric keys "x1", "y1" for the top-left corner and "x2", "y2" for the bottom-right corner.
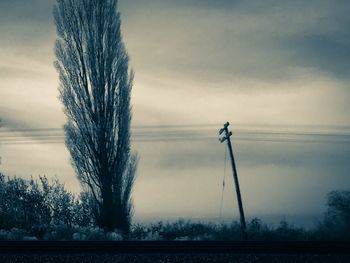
[{"x1": 219, "y1": 122, "x2": 247, "y2": 240}]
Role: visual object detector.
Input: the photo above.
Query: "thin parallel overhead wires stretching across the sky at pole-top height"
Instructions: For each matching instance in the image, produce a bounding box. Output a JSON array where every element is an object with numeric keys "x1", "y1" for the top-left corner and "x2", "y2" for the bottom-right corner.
[{"x1": 0, "y1": 124, "x2": 350, "y2": 145}]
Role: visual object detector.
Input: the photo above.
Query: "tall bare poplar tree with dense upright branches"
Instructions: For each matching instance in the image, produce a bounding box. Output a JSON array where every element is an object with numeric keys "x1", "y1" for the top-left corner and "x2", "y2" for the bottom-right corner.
[{"x1": 53, "y1": 0, "x2": 137, "y2": 232}]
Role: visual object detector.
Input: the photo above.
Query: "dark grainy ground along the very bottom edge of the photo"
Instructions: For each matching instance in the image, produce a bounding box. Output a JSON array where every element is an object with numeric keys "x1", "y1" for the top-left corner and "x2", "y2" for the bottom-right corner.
[{"x1": 0, "y1": 253, "x2": 350, "y2": 263}]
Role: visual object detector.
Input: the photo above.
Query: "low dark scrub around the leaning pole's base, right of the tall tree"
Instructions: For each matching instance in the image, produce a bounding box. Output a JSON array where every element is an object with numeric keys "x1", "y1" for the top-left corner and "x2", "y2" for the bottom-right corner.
[{"x1": 130, "y1": 218, "x2": 312, "y2": 241}]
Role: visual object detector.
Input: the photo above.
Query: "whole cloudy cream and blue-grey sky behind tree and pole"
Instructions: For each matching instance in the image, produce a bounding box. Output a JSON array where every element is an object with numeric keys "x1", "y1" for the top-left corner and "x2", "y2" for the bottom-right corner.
[{"x1": 0, "y1": 0, "x2": 350, "y2": 225}]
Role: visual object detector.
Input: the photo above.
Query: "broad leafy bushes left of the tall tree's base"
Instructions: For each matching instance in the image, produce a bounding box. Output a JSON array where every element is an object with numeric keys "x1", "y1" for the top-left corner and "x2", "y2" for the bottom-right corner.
[{"x1": 0, "y1": 174, "x2": 94, "y2": 237}]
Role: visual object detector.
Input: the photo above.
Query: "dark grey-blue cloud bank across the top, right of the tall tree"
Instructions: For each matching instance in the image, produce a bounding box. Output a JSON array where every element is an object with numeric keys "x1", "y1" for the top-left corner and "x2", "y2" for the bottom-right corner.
[{"x1": 121, "y1": 0, "x2": 350, "y2": 83}]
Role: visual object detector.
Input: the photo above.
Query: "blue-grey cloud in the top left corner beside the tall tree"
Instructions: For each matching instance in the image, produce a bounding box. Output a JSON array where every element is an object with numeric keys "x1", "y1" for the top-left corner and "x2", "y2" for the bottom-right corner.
[{"x1": 0, "y1": 0, "x2": 55, "y2": 56}]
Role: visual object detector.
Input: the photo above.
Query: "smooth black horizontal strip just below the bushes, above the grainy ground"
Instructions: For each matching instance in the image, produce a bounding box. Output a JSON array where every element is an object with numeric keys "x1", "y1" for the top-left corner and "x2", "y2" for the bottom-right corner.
[{"x1": 0, "y1": 241, "x2": 350, "y2": 254}]
